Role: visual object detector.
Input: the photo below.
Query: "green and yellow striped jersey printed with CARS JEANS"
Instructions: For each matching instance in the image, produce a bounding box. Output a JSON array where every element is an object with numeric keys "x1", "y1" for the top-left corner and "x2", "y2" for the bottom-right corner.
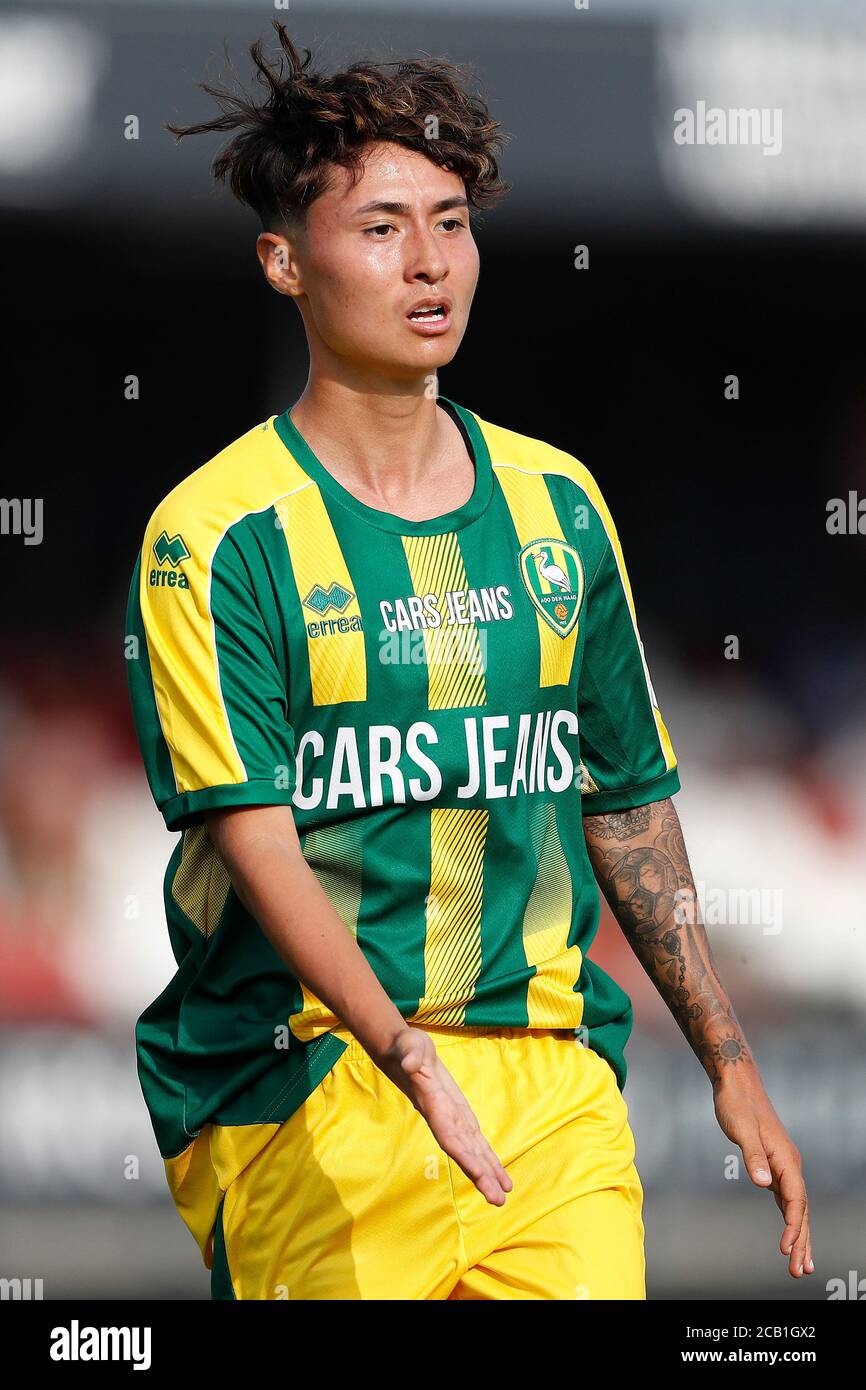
[{"x1": 126, "y1": 398, "x2": 680, "y2": 1217}]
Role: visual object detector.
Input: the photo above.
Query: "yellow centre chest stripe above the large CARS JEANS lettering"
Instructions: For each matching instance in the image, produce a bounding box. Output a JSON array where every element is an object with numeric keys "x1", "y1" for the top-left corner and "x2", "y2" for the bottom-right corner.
[{"x1": 403, "y1": 531, "x2": 487, "y2": 709}]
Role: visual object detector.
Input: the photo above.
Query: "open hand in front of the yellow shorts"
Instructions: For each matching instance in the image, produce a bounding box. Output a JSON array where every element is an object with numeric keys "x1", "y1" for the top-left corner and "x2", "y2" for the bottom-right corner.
[{"x1": 377, "y1": 1027, "x2": 513, "y2": 1207}]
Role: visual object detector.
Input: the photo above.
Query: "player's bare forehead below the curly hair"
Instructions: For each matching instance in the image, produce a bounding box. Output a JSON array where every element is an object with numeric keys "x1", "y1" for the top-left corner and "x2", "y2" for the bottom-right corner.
[{"x1": 317, "y1": 140, "x2": 466, "y2": 215}]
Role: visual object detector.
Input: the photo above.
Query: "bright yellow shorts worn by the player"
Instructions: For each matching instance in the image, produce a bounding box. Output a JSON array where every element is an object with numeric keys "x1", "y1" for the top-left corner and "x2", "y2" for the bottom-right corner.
[{"x1": 211, "y1": 1027, "x2": 646, "y2": 1300}]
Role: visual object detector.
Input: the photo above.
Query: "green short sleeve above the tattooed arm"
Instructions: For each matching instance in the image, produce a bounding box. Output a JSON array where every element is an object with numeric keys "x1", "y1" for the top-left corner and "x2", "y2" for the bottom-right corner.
[{"x1": 577, "y1": 498, "x2": 680, "y2": 816}]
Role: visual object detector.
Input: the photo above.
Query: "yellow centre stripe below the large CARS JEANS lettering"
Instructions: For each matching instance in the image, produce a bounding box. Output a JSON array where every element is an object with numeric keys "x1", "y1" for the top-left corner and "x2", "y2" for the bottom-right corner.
[{"x1": 411, "y1": 808, "x2": 489, "y2": 1027}]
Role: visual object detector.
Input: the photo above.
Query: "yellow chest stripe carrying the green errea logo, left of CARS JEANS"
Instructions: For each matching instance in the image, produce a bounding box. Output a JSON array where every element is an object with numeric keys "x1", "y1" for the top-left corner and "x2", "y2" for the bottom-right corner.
[{"x1": 277, "y1": 482, "x2": 367, "y2": 705}]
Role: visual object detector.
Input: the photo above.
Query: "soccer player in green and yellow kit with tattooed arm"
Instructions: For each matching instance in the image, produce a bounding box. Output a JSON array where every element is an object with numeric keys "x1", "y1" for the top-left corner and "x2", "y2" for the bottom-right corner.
[{"x1": 128, "y1": 22, "x2": 812, "y2": 1300}]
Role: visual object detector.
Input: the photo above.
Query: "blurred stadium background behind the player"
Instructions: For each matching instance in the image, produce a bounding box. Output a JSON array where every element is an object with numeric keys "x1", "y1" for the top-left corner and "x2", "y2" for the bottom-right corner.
[{"x1": 0, "y1": 0, "x2": 866, "y2": 1300}]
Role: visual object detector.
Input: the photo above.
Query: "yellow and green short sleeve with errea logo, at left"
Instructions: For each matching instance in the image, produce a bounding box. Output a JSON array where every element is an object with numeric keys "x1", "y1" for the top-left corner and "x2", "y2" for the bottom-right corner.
[{"x1": 126, "y1": 513, "x2": 295, "y2": 830}]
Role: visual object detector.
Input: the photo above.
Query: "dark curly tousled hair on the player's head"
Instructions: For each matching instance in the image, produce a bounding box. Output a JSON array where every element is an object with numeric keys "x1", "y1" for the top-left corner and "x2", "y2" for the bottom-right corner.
[{"x1": 165, "y1": 19, "x2": 509, "y2": 231}]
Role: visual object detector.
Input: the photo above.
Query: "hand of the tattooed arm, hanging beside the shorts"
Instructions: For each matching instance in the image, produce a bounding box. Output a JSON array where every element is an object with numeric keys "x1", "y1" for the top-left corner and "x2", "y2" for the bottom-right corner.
[{"x1": 714, "y1": 1077, "x2": 815, "y2": 1279}]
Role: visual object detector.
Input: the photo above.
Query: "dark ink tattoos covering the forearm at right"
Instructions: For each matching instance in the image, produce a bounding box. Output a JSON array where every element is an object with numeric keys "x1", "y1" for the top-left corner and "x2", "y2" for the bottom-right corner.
[{"x1": 584, "y1": 796, "x2": 752, "y2": 1084}]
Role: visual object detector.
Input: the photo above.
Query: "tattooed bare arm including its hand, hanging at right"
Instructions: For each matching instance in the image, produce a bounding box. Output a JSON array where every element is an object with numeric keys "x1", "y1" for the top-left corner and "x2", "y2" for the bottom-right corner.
[{"x1": 584, "y1": 796, "x2": 815, "y2": 1279}]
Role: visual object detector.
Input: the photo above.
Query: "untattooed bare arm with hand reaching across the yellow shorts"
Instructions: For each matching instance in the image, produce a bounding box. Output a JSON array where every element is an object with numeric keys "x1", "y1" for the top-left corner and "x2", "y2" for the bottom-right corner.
[{"x1": 207, "y1": 806, "x2": 512, "y2": 1207}]
